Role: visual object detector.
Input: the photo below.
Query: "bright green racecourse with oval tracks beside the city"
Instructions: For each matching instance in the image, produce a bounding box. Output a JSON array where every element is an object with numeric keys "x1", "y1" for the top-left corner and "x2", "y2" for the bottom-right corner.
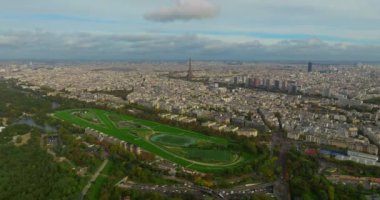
[{"x1": 54, "y1": 109, "x2": 252, "y2": 172}]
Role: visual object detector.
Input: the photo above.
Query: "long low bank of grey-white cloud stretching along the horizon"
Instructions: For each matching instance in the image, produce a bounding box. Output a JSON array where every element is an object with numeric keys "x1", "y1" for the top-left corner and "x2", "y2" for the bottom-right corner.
[{"x1": 0, "y1": 31, "x2": 380, "y2": 61}]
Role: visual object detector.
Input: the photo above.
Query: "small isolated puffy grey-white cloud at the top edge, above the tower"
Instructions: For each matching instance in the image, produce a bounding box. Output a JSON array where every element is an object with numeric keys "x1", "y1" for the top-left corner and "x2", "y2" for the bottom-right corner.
[{"x1": 144, "y1": 0, "x2": 219, "y2": 22}]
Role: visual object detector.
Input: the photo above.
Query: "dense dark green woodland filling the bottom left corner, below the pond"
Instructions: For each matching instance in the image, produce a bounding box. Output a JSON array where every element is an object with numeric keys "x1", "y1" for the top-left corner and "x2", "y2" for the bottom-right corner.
[{"x1": 0, "y1": 125, "x2": 83, "y2": 200}]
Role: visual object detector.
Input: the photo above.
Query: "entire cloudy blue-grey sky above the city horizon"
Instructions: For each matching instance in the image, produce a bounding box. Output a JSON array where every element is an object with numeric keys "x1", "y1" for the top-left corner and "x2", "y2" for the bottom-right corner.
[{"x1": 0, "y1": 0, "x2": 380, "y2": 62}]
